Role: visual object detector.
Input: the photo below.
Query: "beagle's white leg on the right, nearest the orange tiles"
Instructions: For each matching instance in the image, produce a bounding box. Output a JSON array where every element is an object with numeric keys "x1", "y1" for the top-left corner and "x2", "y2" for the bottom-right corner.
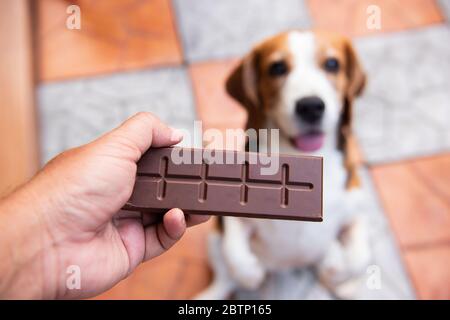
[{"x1": 317, "y1": 218, "x2": 372, "y2": 298}]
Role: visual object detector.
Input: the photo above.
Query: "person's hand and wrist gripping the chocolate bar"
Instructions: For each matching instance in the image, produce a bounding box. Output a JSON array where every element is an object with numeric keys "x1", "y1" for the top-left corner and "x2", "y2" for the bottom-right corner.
[{"x1": 0, "y1": 113, "x2": 208, "y2": 298}]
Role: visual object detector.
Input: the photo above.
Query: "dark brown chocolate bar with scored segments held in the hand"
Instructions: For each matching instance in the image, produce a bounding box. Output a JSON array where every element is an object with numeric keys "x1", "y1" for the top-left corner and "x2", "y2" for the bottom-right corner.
[{"x1": 124, "y1": 147, "x2": 322, "y2": 221}]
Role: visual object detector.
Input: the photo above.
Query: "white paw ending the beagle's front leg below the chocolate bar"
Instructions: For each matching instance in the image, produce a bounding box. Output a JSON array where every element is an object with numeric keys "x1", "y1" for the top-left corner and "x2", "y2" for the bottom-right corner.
[{"x1": 230, "y1": 256, "x2": 266, "y2": 290}]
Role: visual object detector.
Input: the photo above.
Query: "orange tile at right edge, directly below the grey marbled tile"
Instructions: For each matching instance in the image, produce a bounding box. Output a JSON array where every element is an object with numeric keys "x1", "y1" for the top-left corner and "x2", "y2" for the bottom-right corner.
[{"x1": 371, "y1": 154, "x2": 450, "y2": 248}]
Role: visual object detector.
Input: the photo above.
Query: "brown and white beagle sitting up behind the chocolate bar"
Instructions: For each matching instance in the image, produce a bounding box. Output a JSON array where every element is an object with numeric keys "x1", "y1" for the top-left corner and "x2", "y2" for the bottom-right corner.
[{"x1": 197, "y1": 31, "x2": 371, "y2": 299}]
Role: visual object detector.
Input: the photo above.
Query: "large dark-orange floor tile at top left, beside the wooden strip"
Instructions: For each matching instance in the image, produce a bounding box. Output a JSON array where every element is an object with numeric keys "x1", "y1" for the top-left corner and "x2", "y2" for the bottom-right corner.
[{"x1": 37, "y1": 0, "x2": 182, "y2": 81}]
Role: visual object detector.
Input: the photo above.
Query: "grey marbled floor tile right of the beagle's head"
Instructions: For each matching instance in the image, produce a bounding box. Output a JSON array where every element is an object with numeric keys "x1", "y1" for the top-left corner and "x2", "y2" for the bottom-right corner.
[{"x1": 355, "y1": 25, "x2": 450, "y2": 163}]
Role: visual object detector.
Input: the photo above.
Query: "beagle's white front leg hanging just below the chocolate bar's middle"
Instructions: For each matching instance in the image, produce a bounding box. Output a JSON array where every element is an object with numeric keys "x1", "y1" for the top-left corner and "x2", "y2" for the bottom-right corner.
[{"x1": 223, "y1": 217, "x2": 266, "y2": 289}]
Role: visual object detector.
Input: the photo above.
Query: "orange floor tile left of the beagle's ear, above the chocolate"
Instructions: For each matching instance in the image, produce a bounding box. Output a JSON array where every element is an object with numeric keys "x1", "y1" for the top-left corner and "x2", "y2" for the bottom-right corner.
[{"x1": 189, "y1": 60, "x2": 247, "y2": 135}]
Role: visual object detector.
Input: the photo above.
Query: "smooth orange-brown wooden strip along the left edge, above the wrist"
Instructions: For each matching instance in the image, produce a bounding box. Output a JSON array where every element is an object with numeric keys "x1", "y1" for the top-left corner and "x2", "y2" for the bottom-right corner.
[{"x1": 0, "y1": 0, "x2": 39, "y2": 196}]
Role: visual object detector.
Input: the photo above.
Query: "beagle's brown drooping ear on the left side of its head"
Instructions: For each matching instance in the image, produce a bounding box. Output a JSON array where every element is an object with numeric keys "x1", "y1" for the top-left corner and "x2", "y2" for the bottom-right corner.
[{"x1": 226, "y1": 49, "x2": 264, "y2": 129}]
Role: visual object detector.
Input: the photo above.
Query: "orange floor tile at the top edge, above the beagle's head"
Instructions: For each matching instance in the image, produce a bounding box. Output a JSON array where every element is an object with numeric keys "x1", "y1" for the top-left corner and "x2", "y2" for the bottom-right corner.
[{"x1": 307, "y1": 0, "x2": 444, "y2": 36}]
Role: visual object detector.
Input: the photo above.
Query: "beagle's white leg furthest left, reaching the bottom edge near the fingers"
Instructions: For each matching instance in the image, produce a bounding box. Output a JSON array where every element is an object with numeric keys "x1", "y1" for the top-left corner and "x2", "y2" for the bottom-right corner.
[{"x1": 194, "y1": 231, "x2": 236, "y2": 300}]
